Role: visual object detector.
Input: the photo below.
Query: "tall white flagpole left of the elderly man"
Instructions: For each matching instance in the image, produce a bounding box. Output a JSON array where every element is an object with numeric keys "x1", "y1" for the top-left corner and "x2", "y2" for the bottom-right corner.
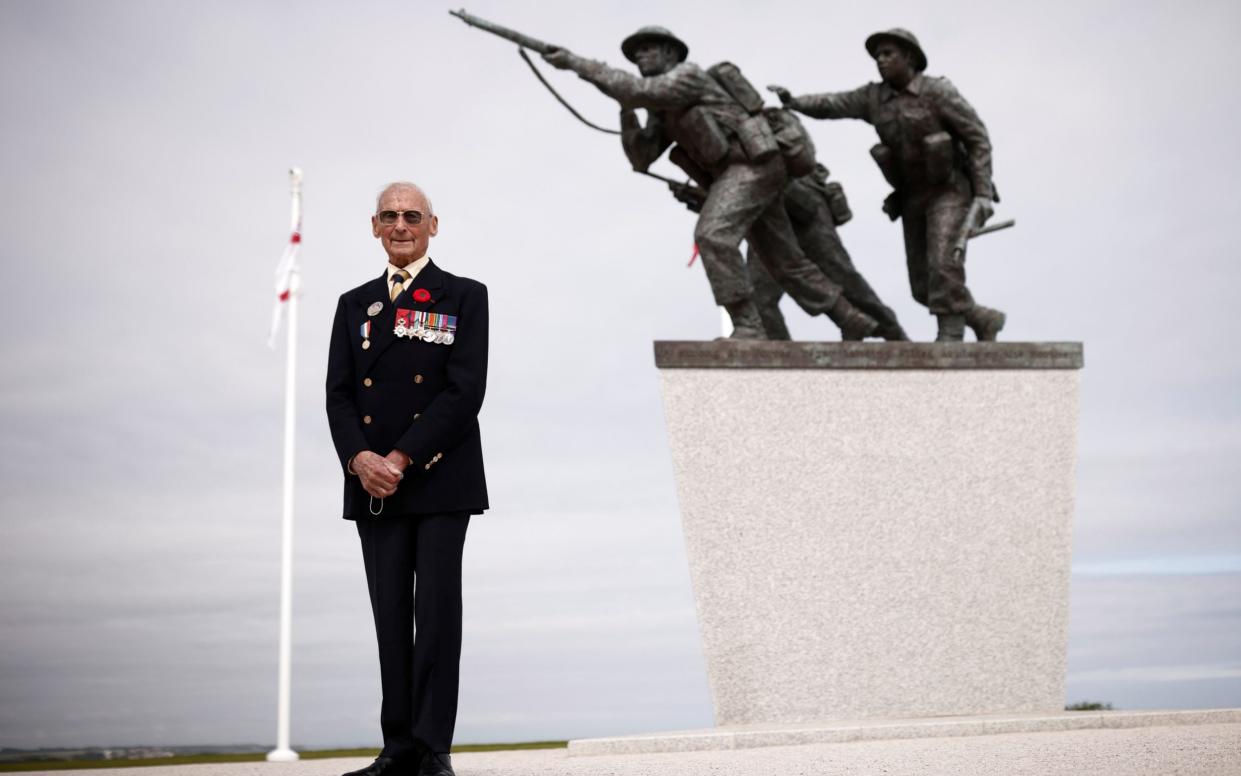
[{"x1": 267, "y1": 168, "x2": 302, "y2": 762}]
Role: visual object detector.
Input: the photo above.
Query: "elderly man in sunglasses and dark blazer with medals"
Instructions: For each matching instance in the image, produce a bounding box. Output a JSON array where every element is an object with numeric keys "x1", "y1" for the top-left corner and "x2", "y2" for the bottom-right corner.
[{"x1": 328, "y1": 183, "x2": 488, "y2": 776}]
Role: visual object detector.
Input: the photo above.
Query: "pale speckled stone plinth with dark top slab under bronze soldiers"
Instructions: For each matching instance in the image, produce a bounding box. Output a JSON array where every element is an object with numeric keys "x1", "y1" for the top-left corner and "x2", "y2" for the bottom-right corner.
[{"x1": 655, "y1": 341, "x2": 1082, "y2": 725}]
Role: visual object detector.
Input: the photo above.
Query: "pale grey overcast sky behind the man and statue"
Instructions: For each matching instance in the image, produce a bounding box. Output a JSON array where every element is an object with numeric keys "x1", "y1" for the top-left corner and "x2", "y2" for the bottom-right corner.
[{"x1": 0, "y1": 0, "x2": 1241, "y2": 746}]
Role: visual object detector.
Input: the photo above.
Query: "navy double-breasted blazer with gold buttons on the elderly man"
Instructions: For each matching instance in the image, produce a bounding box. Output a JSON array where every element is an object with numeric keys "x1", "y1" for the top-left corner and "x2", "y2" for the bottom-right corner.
[{"x1": 328, "y1": 261, "x2": 488, "y2": 520}]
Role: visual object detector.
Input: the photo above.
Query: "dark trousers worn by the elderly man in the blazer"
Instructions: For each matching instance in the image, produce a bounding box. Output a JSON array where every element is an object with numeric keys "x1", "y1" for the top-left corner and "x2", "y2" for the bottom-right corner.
[{"x1": 357, "y1": 514, "x2": 469, "y2": 759}]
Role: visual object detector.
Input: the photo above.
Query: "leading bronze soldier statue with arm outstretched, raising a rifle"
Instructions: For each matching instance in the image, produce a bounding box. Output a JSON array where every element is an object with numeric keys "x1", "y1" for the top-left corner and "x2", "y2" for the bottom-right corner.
[{"x1": 544, "y1": 27, "x2": 876, "y2": 340}]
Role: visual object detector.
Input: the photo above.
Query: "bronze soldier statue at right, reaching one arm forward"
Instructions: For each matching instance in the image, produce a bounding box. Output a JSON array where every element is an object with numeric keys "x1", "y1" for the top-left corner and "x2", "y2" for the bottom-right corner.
[{"x1": 771, "y1": 29, "x2": 1004, "y2": 341}]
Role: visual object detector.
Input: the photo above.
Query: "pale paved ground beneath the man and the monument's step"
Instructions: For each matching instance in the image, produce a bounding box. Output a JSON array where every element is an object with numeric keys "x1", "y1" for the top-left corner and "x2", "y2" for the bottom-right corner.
[{"x1": 16, "y1": 724, "x2": 1241, "y2": 776}]
